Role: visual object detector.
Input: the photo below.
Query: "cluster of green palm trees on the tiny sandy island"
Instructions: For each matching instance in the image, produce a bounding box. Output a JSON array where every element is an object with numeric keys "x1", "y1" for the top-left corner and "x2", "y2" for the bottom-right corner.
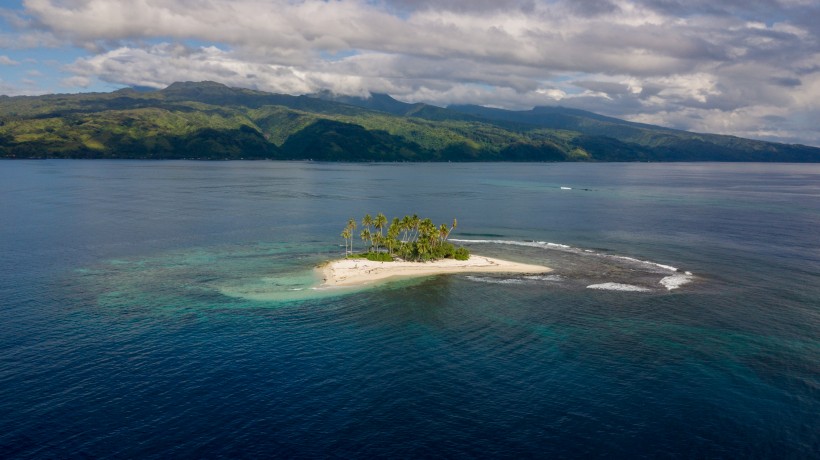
[{"x1": 342, "y1": 213, "x2": 469, "y2": 261}]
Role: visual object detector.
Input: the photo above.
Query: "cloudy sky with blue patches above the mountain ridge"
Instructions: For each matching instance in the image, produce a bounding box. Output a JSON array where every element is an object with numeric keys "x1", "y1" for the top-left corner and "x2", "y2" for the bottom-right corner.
[{"x1": 0, "y1": 0, "x2": 820, "y2": 146}]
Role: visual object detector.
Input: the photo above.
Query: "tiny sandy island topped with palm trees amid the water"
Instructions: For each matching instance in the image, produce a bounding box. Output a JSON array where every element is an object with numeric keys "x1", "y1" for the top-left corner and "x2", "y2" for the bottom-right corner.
[{"x1": 317, "y1": 213, "x2": 552, "y2": 287}]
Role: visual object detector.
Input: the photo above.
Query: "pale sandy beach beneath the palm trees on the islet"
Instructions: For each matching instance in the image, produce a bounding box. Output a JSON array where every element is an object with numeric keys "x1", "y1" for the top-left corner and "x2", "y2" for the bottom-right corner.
[{"x1": 317, "y1": 255, "x2": 552, "y2": 287}]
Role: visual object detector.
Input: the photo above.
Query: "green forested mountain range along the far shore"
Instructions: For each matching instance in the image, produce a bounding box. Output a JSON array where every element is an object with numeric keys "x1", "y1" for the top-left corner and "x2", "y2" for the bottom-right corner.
[{"x1": 0, "y1": 82, "x2": 820, "y2": 162}]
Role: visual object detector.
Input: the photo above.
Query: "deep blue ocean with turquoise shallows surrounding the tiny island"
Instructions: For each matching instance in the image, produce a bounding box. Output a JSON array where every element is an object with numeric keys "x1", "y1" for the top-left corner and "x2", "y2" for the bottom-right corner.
[{"x1": 0, "y1": 160, "x2": 820, "y2": 459}]
